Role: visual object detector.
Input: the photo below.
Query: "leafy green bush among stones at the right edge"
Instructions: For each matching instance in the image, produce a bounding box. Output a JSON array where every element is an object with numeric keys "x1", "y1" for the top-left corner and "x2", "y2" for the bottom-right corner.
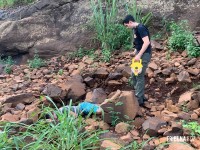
[{"x1": 168, "y1": 20, "x2": 200, "y2": 57}]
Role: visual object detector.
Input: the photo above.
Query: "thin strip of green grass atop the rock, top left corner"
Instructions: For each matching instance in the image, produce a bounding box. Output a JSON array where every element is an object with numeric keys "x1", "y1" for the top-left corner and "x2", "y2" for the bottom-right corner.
[{"x1": 0, "y1": 0, "x2": 35, "y2": 8}]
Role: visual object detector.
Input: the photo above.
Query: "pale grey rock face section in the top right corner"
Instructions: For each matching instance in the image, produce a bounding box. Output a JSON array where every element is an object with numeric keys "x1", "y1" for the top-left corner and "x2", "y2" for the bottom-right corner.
[{"x1": 139, "y1": 0, "x2": 200, "y2": 29}]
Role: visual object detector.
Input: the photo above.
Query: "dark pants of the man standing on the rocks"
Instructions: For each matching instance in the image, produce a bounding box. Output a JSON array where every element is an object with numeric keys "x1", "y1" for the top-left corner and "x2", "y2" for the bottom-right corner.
[{"x1": 132, "y1": 53, "x2": 151, "y2": 104}]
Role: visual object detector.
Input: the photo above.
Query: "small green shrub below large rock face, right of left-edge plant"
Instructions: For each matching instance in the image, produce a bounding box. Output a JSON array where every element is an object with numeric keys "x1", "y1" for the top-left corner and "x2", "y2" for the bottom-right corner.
[{"x1": 28, "y1": 54, "x2": 46, "y2": 69}]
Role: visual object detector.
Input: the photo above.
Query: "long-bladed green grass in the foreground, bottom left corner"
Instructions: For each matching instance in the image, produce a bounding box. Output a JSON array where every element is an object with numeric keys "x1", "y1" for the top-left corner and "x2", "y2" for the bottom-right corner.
[{"x1": 0, "y1": 98, "x2": 107, "y2": 150}]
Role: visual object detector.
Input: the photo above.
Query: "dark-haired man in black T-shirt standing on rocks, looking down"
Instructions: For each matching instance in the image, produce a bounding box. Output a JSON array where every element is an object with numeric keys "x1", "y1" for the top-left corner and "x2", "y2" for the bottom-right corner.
[{"x1": 123, "y1": 15, "x2": 151, "y2": 106}]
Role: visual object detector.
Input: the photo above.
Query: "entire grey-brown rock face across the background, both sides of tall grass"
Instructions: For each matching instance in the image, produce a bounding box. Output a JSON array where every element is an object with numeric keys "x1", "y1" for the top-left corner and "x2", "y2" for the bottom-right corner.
[{"x1": 0, "y1": 0, "x2": 200, "y2": 61}]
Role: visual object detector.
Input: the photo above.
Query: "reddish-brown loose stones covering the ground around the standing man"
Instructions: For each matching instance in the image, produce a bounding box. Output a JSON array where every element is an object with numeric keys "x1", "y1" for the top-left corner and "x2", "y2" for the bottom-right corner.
[{"x1": 0, "y1": 42, "x2": 200, "y2": 150}]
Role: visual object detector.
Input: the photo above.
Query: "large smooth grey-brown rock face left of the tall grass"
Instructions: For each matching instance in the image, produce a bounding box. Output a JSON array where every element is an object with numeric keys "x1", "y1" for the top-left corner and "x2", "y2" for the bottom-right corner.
[{"x1": 0, "y1": 0, "x2": 91, "y2": 57}]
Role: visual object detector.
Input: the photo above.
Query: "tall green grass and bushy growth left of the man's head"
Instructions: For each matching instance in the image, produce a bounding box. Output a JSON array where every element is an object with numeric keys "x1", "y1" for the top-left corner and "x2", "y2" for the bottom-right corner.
[{"x1": 90, "y1": 0, "x2": 131, "y2": 61}]
